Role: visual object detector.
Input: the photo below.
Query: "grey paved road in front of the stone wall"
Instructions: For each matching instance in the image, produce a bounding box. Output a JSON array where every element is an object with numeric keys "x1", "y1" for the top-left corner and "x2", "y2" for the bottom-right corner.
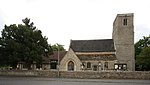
[{"x1": 0, "y1": 76, "x2": 150, "y2": 85}]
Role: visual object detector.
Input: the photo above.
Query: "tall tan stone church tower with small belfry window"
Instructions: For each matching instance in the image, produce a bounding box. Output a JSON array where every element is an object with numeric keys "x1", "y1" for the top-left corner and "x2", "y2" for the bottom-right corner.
[{"x1": 112, "y1": 13, "x2": 135, "y2": 71}]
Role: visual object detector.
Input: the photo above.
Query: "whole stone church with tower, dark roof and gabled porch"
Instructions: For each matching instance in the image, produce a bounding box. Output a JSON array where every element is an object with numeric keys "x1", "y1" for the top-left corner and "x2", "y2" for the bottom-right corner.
[{"x1": 59, "y1": 13, "x2": 135, "y2": 71}]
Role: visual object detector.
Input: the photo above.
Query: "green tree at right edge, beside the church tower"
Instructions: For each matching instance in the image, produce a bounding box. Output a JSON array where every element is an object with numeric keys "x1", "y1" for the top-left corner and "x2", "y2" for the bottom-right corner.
[{"x1": 135, "y1": 35, "x2": 150, "y2": 71}]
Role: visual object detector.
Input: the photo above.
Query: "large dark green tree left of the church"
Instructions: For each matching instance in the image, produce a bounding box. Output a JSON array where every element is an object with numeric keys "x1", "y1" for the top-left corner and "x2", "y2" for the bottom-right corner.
[{"x1": 0, "y1": 18, "x2": 52, "y2": 68}]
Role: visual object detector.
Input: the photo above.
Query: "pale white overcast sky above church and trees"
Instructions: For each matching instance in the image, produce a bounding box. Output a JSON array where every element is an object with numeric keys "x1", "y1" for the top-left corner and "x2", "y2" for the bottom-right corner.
[{"x1": 0, "y1": 0, "x2": 150, "y2": 50}]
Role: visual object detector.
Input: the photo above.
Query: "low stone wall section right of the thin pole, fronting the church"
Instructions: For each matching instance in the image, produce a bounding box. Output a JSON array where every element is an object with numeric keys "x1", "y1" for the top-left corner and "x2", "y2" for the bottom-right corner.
[{"x1": 61, "y1": 72, "x2": 150, "y2": 79}]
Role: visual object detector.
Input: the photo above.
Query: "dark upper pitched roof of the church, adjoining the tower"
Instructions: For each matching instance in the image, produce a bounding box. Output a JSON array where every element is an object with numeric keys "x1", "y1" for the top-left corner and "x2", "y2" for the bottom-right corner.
[{"x1": 70, "y1": 39, "x2": 115, "y2": 52}]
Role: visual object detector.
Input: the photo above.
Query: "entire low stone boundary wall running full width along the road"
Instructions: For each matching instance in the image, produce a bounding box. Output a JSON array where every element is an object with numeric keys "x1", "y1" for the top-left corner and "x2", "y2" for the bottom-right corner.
[{"x1": 0, "y1": 70, "x2": 150, "y2": 80}]
